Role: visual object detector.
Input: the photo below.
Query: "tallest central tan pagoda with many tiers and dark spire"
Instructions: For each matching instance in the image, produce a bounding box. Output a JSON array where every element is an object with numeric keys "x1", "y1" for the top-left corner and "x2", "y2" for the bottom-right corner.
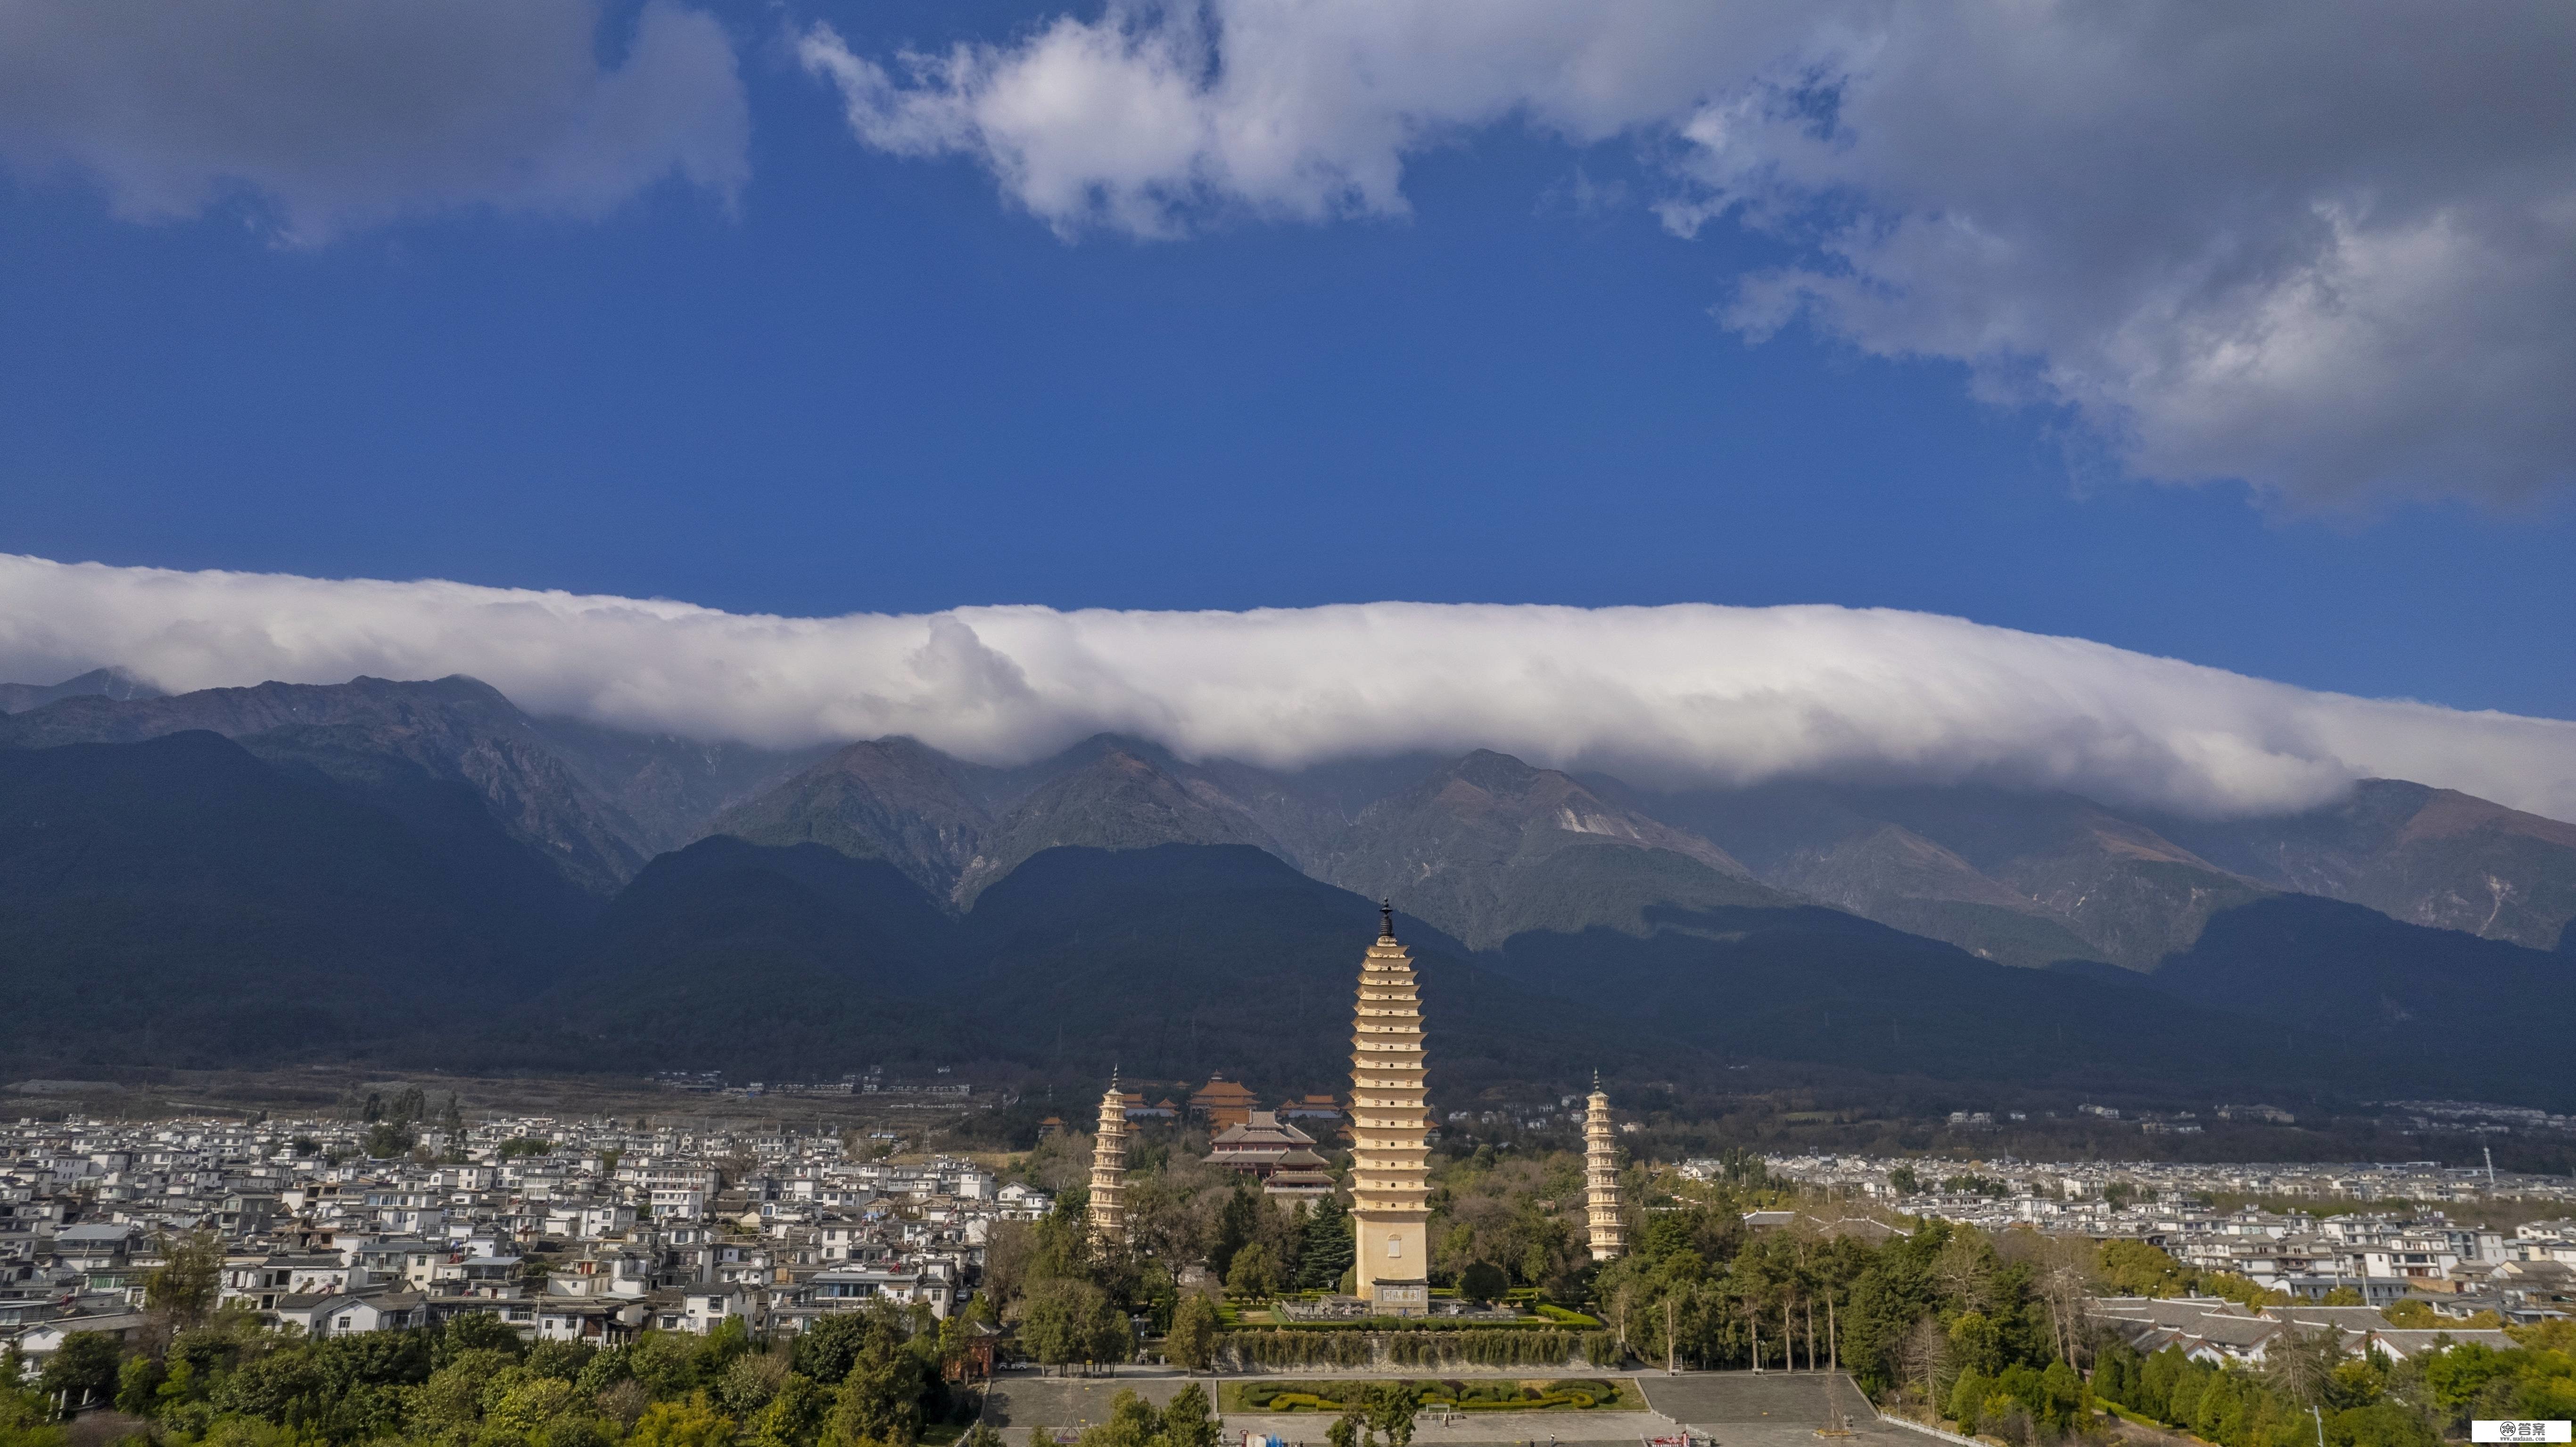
[{"x1": 1350, "y1": 906, "x2": 1432, "y2": 1315}]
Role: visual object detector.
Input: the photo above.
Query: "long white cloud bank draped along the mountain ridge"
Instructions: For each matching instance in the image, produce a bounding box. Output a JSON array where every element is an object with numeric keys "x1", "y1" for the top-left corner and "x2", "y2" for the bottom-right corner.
[{"x1": 0, "y1": 556, "x2": 2576, "y2": 819}]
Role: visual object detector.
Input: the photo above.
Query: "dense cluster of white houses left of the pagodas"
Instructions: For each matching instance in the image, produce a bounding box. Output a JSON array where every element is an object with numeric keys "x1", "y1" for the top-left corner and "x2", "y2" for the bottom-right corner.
[{"x1": 0, "y1": 1118, "x2": 1054, "y2": 1367}]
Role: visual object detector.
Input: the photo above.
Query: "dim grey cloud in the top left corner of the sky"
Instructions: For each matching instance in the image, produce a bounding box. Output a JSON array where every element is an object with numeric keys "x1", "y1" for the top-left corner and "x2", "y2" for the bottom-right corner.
[{"x1": 0, "y1": 0, "x2": 750, "y2": 242}]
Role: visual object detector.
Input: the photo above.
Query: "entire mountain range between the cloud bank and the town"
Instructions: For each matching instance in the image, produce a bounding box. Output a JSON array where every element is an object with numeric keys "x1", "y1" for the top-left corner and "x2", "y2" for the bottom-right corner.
[{"x1": 0, "y1": 669, "x2": 2576, "y2": 1100}]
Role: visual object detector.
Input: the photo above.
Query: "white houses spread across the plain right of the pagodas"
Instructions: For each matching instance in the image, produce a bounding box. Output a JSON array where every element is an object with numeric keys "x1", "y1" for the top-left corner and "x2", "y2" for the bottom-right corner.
[{"x1": 1767, "y1": 1156, "x2": 2576, "y2": 1331}]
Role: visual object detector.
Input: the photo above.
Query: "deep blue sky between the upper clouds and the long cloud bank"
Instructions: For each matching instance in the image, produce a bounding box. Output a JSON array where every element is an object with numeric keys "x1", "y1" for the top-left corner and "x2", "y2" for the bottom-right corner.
[{"x1": 0, "y1": 5, "x2": 2576, "y2": 718}]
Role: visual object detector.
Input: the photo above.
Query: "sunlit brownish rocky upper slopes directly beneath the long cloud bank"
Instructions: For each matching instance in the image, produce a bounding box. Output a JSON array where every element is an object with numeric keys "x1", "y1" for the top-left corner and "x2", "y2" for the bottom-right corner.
[{"x1": 15, "y1": 669, "x2": 2576, "y2": 970}]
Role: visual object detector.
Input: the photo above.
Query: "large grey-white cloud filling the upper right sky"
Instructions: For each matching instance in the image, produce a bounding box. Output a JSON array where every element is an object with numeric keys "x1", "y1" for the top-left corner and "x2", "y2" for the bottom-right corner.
[{"x1": 801, "y1": 0, "x2": 2576, "y2": 507}]
